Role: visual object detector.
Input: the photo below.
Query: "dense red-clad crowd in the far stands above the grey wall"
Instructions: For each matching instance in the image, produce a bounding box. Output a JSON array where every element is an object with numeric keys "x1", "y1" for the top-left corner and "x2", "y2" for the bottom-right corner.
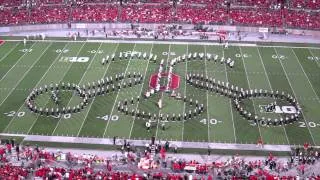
[{"x1": 0, "y1": 0, "x2": 320, "y2": 29}]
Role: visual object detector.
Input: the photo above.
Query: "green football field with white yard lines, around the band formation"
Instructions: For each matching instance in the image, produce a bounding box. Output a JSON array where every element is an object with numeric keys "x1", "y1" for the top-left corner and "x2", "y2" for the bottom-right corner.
[{"x1": 0, "y1": 41, "x2": 320, "y2": 145}]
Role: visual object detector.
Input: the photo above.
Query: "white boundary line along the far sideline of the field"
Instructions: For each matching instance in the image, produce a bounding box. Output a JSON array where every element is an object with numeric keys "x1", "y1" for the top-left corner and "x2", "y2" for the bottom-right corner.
[{"x1": 6, "y1": 39, "x2": 320, "y2": 49}]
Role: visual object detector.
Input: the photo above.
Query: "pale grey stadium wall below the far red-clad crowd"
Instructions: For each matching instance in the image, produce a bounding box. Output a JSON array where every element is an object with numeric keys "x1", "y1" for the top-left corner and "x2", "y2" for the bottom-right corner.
[{"x1": 0, "y1": 23, "x2": 320, "y2": 37}]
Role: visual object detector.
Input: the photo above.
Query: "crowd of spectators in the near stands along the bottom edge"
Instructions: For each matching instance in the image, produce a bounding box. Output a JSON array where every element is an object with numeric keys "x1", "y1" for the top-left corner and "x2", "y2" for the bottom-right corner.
[{"x1": 0, "y1": 140, "x2": 320, "y2": 180}]
